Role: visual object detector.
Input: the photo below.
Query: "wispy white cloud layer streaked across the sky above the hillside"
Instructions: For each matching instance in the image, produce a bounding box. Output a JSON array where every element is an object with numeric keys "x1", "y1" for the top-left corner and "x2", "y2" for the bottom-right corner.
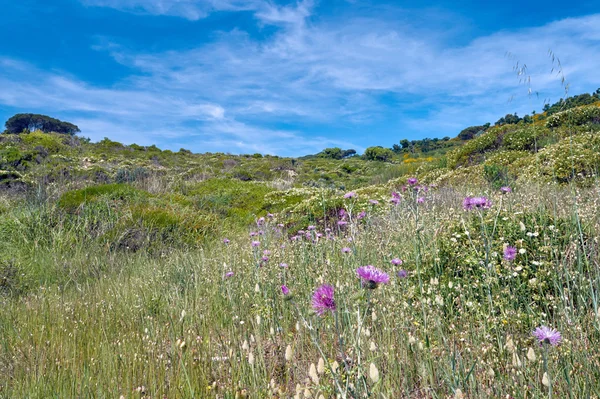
[{"x1": 0, "y1": 0, "x2": 600, "y2": 155}]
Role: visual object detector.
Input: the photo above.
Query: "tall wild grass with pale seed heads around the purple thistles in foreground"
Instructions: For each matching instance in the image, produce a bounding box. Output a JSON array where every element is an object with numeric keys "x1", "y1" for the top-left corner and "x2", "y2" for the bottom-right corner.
[{"x1": 0, "y1": 182, "x2": 600, "y2": 398}]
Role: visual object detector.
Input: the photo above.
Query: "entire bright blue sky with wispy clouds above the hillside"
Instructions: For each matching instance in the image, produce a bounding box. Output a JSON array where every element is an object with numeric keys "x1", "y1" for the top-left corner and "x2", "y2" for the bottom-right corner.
[{"x1": 0, "y1": 0, "x2": 600, "y2": 156}]
